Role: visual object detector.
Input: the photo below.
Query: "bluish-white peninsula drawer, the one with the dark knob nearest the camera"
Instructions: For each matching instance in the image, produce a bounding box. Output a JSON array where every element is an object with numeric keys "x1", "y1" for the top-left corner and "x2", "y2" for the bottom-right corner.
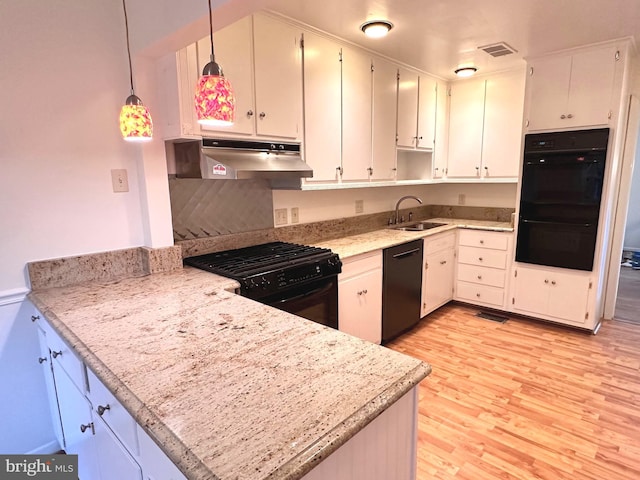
[{"x1": 87, "y1": 369, "x2": 139, "y2": 455}]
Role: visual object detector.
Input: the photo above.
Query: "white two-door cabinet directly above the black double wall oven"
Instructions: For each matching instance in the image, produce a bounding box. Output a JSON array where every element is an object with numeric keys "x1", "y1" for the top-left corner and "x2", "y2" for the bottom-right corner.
[{"x1": 527, "y1": 44, "x2": 622, "y2": 131}]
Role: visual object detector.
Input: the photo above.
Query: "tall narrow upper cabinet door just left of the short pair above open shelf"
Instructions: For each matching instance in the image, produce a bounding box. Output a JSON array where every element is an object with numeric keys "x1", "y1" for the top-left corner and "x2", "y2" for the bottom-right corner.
[{"x1": 371, "y1": 58, "x2": 398, "y2": 180}]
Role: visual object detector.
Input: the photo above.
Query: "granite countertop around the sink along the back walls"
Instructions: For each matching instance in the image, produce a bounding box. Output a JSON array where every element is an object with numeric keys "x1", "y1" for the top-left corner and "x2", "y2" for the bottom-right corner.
[{"x1": 315, "y1": 218, "x2": 513, "y2": 260}]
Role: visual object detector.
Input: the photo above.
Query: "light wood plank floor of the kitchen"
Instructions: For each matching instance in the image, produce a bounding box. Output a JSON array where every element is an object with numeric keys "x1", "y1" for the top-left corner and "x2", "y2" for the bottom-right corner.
[{"x1": 388, "y1": 304, "x2": 640, "y2": 480}]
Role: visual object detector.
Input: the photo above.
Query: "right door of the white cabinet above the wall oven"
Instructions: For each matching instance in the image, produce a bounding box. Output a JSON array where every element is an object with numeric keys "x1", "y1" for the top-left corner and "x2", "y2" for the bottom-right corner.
[{"x1": 563, "y1": 45, "x2": 617, "y2": 127}]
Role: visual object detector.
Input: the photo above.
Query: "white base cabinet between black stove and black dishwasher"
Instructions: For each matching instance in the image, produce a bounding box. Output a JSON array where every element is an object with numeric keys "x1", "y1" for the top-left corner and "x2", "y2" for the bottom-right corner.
[{"x1": 338, "y1": 250, "x2": 382, "y2": 344}]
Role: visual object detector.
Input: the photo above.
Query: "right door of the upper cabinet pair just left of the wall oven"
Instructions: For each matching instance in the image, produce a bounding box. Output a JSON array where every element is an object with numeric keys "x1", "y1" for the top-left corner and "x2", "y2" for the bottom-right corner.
[{"x1": 482, "y1": 70, "x2": 525, "y2": 178}]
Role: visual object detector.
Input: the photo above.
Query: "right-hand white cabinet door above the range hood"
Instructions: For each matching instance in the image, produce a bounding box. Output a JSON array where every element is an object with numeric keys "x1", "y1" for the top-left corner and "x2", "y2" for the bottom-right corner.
[{"x1": 252, "y1": 15, "x2": 302, "y2": 139}]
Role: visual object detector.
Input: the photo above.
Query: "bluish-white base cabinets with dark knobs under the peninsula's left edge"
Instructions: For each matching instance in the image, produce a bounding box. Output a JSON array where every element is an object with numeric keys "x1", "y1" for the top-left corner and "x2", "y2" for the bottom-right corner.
[{"x1": 31, "y1": 311, "x2": 186, "y2": 480}]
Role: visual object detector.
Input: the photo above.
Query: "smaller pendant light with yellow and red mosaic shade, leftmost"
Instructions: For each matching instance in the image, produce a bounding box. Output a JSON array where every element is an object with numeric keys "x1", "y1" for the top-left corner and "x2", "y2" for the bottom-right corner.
[{"x1": 120, "y1": 0, "x2": 153, "y2": 142}]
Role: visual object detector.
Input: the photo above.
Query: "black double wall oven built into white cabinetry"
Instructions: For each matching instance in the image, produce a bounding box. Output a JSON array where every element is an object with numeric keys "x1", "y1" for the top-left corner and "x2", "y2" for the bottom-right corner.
[{"x1": 516, "y1": 128, "x2": 609, "y2": 271}]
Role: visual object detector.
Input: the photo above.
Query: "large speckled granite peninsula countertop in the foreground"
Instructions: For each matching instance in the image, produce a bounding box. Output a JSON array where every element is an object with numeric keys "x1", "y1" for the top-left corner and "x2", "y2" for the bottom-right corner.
[{"x1": 29, "y1": 268, "x2": 431, "y2": 479}]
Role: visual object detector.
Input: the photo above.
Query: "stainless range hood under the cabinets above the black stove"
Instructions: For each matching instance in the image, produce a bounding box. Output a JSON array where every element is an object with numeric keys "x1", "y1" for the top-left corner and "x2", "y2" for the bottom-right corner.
[{"x1": 174, "y1": 138, "x2": 313, "y2": 189}]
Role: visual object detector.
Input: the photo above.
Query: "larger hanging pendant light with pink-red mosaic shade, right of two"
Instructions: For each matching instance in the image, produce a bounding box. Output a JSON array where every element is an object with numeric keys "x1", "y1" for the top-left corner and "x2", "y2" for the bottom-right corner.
[{"x1": 194, "y1": 0, "x2": 236, "y2": 127}]
